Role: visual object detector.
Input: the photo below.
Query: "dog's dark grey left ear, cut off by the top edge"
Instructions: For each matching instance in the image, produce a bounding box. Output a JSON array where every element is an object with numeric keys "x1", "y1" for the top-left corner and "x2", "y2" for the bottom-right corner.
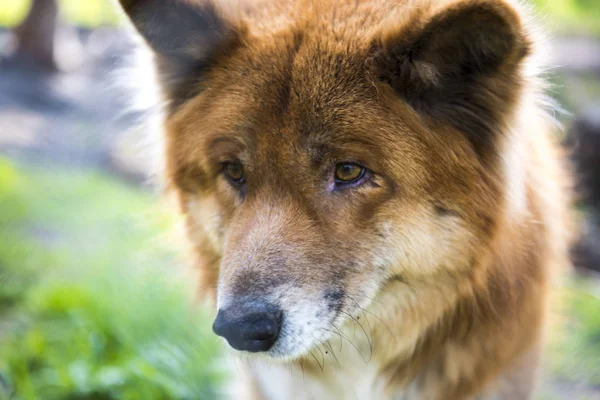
[{"x1": 119, "y1": 0, "x2": 243, "y2": 107}]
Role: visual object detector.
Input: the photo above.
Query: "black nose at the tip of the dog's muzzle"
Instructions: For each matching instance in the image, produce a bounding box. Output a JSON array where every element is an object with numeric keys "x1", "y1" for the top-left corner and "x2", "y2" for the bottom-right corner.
[{"x1": 213, "y1": 300, "x2": 283, "y2": 353}]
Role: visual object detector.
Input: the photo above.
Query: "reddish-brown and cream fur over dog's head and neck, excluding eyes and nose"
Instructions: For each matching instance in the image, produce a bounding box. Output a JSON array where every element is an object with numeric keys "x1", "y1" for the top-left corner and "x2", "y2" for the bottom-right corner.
[{"x1": 119, "y1": 0, "x2": 569, "y2": 400}]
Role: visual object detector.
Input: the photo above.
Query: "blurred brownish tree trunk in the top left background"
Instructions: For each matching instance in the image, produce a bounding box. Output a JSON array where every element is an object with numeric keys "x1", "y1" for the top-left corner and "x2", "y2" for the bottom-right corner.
[{"x1": 15, "y1": 0, "x2": 58, "y2": 71}]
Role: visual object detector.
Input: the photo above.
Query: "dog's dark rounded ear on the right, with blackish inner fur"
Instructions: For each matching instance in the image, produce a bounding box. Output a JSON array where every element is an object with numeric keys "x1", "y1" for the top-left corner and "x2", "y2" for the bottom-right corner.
[{"x1": 372, "y1": 0, "x2": 529, "y2": 155}]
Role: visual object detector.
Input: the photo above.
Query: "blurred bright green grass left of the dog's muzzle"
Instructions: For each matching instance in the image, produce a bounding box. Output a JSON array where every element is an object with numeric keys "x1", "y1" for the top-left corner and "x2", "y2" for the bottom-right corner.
[{"x1": 0, "y1": 158, "x2": 224, "y2": 400}]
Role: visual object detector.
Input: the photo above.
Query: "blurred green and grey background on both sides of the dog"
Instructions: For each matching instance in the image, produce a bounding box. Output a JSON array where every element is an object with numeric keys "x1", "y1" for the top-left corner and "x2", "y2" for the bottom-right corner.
[{"x1": 0, "y1": 0, "x2": 600, "y2": 400}]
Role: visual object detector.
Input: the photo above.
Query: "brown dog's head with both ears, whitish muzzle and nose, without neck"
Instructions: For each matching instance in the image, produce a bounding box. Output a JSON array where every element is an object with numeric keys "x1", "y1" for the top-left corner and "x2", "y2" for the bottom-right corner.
[{"x1": 121, "y1": 0, "x2": 529, "y2": 359}]
